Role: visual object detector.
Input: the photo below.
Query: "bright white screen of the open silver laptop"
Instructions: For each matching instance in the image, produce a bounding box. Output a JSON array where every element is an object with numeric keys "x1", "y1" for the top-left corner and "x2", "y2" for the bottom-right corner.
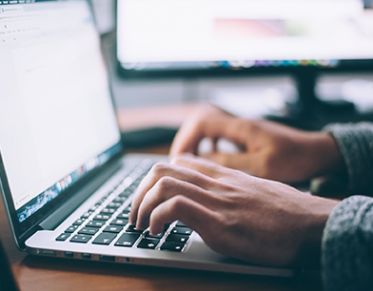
[{"x1": 0, "y1": 1, "x2": 121, "y2": 222}]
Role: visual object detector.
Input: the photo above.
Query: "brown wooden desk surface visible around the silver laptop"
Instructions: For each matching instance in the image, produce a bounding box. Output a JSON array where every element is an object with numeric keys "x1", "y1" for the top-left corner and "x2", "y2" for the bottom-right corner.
[{"x1": 0, "y1": 106, "x2": 318, "y2": 291}]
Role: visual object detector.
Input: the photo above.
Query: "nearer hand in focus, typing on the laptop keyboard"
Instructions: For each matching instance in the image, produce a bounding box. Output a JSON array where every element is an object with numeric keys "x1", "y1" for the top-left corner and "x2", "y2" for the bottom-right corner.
[{"x1": 130, "y1": 156, "x2": 337, "y2": 266}]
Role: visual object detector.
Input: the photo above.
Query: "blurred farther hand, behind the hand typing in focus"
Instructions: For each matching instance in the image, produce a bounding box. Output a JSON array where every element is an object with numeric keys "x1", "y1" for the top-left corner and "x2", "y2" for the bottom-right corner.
[{"x1": 171, "y1": 106, "x2": 342, "y2": 183}]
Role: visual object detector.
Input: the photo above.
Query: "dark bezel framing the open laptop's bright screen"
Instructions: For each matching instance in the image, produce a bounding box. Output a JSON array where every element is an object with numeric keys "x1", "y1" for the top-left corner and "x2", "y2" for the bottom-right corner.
[{"x1": 0, "y1": 0, "x2": 124, "y2": 249}]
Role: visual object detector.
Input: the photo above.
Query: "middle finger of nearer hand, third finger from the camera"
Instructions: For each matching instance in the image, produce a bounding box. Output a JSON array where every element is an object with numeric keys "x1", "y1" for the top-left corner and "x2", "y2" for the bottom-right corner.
[{"x1": 130, "y1": 163, "x2": 213, "y2": 223}]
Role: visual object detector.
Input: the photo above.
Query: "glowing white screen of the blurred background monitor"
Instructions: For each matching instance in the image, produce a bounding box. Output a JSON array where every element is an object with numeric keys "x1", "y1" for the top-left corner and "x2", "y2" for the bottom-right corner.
[{"x1": 117, "y1": 0, "x2": 373, "y2": 72}]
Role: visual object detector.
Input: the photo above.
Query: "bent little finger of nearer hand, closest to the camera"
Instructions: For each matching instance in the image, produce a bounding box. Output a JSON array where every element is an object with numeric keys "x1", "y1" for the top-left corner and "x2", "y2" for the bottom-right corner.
[{"x1": 150, "y1": 196, "x2": 218, "y2": 237}]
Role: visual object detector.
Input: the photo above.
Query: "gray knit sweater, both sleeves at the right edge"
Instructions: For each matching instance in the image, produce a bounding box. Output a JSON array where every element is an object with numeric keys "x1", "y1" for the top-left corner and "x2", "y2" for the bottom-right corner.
[{"x1": 321, "y1": 123, "x2": 373, "y2": 291}]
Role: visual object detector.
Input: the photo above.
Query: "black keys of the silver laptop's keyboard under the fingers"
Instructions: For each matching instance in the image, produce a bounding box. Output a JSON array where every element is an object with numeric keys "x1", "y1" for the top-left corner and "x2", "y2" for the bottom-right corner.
[{"x1": 56, "y1": 161, "x2": 193, "y2": 252}]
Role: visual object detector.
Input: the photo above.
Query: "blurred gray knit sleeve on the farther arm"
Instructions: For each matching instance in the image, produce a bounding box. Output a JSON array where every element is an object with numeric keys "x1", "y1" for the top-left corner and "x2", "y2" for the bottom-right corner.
[{"x1": 325, "y1": 123, "x2": 373, "y2": 195}]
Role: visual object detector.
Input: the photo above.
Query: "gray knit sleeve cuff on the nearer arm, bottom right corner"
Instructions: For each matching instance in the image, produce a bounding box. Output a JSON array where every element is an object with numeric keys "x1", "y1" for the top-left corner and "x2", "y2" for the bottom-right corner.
[{"x1": 321, "y1": 196, "x2": 373, "y2": 291}]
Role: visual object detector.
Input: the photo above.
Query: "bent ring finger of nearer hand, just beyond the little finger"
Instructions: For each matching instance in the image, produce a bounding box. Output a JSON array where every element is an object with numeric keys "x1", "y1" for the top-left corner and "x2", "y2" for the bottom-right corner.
[{"x1": 136, "y1": 177, "x2": 221, "y2": 229}]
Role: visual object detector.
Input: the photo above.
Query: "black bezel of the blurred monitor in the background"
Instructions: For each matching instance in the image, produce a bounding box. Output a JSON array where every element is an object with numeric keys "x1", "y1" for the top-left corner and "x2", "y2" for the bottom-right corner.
[{"x1": 114, "y1": 0, "x2": 373, "y2": 79}]
